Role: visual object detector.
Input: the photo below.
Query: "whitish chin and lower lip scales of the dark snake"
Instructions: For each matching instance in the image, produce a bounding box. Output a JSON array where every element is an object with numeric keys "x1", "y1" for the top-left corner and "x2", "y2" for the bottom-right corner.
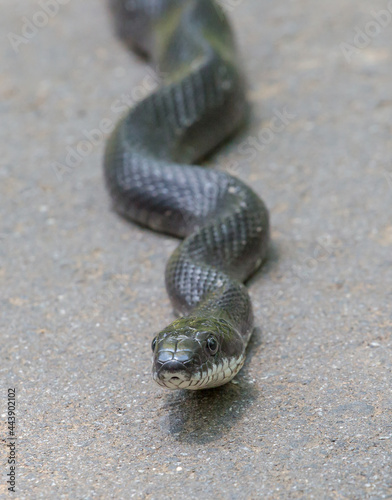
[{"x1": 153, "y1": 354, "x2": 245, "y2": 391}]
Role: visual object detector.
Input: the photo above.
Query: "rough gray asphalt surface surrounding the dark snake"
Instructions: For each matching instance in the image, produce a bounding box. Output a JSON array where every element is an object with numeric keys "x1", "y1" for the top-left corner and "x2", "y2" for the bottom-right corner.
[{"x1": 0, "y1": 0, "x2": 392, "y2": 499}]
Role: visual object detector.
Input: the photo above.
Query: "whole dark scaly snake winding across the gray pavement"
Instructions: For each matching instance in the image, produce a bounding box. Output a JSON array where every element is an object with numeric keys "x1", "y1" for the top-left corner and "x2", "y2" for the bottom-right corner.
[{"x1": 104, "y1": 0, "x2": 270, "y2": 390}]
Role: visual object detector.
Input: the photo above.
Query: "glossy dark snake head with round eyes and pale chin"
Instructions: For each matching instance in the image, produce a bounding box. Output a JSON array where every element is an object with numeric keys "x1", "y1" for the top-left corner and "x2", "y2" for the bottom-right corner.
[{"x1": 152, "y1": 317, "x2": 245, "y2": 390}]
